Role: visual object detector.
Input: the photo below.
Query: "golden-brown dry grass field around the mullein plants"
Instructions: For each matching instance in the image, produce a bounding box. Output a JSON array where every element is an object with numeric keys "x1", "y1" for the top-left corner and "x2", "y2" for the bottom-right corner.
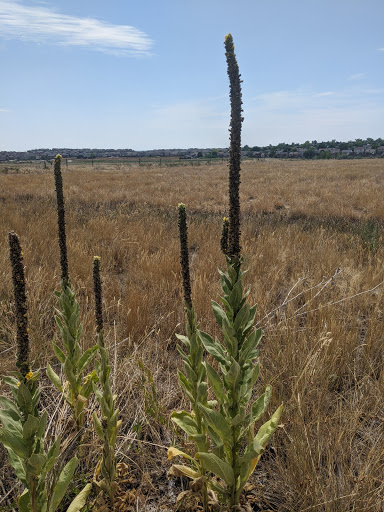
[{"x1": 0, "y1": 160, "x2": 384, "y2": 512}]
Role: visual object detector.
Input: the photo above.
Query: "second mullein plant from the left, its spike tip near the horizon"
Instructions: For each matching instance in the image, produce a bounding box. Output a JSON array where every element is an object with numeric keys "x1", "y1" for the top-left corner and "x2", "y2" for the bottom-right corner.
[{"x1": 47, "y1": 155, "x2": 97, "y2": 430}]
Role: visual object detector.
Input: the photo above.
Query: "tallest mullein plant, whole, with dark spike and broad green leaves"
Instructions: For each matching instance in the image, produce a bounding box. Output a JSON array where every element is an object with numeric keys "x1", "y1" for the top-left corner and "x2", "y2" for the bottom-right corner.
[{"x1": 197, "y1": 34, "x2": 282, "y2": 510}]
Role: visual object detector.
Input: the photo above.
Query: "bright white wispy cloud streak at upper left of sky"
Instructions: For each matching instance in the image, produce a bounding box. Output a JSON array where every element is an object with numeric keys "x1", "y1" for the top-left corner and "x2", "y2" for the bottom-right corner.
[{"x1": 0, "y1": 0, "x2": 153, "y2": 55}]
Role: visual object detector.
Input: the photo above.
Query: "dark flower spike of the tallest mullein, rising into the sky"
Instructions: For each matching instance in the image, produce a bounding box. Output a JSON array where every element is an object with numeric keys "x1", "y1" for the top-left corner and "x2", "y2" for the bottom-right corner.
[{"x1": 224, "y1": 34, "x2": 243, "y2": 262}]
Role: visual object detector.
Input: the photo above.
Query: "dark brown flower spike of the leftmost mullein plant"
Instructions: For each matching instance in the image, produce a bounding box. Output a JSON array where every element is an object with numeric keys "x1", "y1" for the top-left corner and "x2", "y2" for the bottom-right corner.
[{"x1": 8, "y1": 231, "x2": 30, "y2": 378}]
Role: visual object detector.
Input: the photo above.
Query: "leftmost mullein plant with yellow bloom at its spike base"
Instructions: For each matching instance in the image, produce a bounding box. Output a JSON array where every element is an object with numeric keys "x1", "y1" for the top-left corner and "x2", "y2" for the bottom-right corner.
[{"x1": 0, "y1": 232, "x2": 92, "y2": 512}]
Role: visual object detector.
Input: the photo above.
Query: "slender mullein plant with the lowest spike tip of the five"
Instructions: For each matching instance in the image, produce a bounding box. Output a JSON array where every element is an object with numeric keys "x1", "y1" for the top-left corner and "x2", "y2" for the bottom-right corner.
[{"x1": 92, "y1": 256, "x2": 121, "y2": 510}]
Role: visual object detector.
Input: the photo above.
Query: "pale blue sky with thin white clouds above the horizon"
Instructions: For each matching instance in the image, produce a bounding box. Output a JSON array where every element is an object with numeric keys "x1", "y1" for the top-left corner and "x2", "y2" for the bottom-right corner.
[{"x1": 0, "y1": 0, "x2": 384, "y2": 151}]
